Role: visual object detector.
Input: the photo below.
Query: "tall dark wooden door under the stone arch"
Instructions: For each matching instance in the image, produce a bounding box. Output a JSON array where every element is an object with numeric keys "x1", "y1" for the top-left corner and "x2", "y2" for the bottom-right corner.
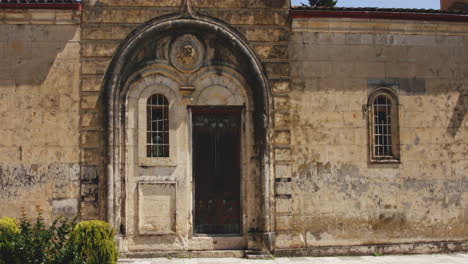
[{"x1": 192, "y1": 107, "x2": 241, "y2": 234}]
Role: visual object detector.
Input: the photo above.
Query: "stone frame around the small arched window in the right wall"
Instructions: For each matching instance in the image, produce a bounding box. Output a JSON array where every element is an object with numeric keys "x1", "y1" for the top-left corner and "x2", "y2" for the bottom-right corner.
[{"x1": 367, "y1": 87, "x2": 400, "y2": 164}]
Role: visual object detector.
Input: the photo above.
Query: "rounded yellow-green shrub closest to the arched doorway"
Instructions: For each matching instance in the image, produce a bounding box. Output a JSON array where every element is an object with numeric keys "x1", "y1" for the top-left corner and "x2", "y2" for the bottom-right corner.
[{"x1": 73, "y1": 220, "x2": 118, "y2": 264}]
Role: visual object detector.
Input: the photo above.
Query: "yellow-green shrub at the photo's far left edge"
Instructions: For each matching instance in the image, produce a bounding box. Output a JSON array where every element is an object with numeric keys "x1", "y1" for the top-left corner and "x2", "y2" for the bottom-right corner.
[{"x1": 0, "y1": 217, "x2": 20, "y2": 264}]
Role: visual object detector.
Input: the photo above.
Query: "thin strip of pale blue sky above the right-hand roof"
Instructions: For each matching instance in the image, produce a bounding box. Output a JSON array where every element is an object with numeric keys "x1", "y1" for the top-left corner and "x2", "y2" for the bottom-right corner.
[{"x1": 292, "y1": 0, "x2": 440, "y2": 9}]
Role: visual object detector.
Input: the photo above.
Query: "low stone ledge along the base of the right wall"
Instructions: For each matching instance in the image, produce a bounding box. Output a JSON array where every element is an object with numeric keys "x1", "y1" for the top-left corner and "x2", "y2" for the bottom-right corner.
[{"x1": 274, "y1": 240, "x2": 468, "y2": 257}]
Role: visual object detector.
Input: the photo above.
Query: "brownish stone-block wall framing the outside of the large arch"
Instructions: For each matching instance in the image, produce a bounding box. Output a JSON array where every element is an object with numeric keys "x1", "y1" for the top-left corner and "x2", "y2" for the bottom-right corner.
[{"x1": 81, "y1": 0, "x2": 290, "y2": 227}]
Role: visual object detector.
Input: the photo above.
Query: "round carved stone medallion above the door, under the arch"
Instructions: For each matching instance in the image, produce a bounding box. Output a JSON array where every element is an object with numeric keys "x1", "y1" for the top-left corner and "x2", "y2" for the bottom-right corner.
[{"x1": 170, "y1": 34, "x2": 205, "y2": 71}]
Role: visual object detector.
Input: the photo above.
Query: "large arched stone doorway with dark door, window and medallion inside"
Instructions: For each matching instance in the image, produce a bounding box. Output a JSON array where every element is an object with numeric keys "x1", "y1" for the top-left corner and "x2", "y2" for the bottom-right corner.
[{"x1": 104, "y1": 11, "x2": 272, "y2": 253}]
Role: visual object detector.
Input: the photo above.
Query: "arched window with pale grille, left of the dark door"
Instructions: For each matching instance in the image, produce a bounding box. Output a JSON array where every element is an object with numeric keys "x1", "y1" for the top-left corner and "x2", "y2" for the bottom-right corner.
[{"x1": 146, "y1": 94, "x2": 169, "y2": 158}]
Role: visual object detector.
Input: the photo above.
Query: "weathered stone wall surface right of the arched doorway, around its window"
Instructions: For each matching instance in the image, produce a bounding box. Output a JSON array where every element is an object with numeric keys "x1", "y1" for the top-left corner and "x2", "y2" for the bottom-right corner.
[{"x1": 288, "y1": 18, "x2": 468, "y2": 249}]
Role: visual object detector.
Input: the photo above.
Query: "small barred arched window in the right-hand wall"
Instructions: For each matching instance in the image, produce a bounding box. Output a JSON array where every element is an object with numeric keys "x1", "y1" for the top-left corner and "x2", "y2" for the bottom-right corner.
[{"x1": 369, "y1": 88, "x2": 400, "y2": 162}]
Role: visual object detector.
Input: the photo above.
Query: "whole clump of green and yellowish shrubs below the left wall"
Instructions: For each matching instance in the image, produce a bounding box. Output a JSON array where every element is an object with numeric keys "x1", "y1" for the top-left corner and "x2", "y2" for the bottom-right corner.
[{"x1": 0, "y1": 208, "x2": 118, "y2": 264}]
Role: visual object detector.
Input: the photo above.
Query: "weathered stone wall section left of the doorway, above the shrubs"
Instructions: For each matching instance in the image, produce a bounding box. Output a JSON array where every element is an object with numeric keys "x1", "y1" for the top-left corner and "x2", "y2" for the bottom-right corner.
[{"x1": 0, "y1": 9, "x2": 80, "y2": 222}]
